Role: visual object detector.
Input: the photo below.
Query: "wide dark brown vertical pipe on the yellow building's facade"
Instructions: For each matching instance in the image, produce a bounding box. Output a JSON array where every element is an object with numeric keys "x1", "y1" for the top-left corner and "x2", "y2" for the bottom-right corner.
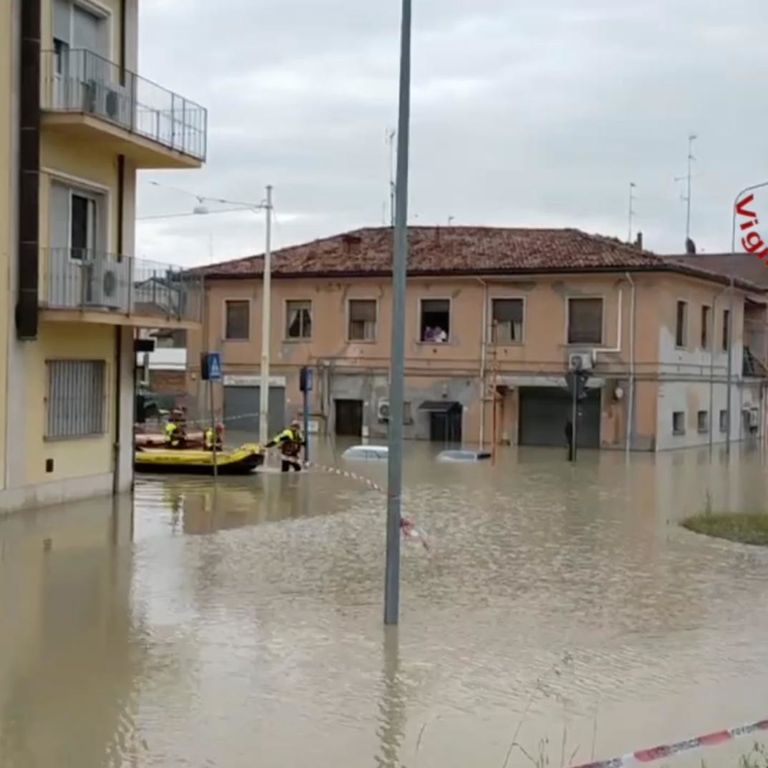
[{"x1": 15, "y1": 0, "x2": 42, "y2": 341}]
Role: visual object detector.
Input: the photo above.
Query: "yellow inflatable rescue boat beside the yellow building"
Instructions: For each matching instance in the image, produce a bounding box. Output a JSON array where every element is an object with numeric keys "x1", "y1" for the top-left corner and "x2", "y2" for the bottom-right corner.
[{"x1": 133, "y1": 443, "x2": 264, "y2": 475}]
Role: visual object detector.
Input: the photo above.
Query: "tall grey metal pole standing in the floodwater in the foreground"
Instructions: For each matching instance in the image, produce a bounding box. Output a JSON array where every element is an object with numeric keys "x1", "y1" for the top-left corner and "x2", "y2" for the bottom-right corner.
[{"x1": 384, "y1": 0, "x2": 411, "y2": 625}]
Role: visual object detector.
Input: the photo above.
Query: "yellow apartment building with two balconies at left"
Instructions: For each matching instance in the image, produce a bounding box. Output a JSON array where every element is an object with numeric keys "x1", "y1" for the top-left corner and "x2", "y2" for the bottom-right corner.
[{"x1": 0, "y1": 0, "x2": 207, "y2": 511}]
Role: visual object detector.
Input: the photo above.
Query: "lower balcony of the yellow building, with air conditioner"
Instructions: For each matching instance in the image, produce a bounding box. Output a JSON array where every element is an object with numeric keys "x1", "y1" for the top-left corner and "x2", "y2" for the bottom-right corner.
[{"x1": 40, "y1": 248, "x2": 203, "y2": 329}]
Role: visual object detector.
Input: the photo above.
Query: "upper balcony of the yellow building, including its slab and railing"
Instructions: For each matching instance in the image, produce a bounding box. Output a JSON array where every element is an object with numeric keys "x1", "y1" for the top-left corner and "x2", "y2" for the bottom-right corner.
[{"x1": 41, "y1": 49, "x2": 208, "y2": 168}]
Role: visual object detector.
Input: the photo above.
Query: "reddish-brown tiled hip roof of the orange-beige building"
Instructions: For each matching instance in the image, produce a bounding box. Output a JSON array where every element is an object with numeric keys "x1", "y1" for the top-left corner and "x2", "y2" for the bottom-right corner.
[{"x1": 192, "y1": 226, "x2": 760, "y2": 291}]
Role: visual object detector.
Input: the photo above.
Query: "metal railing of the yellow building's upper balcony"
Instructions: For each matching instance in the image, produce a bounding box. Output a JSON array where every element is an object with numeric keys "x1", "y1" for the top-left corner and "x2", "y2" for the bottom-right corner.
[{"x1": 42, "y1": 49, "x2": 208, "y2": 161}]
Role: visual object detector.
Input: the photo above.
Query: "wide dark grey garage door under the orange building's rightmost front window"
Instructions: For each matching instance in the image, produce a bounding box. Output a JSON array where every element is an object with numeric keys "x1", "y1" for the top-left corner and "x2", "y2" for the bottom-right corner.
[{"x1": 519, "y1": 387, "x2": 600, "y2": 448}]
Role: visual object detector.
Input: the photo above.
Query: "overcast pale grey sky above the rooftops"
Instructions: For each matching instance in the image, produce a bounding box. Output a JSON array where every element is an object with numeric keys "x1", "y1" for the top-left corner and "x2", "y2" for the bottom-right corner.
[{"x1": 137, "y1": 0, "x2": 768, "y2": 264}]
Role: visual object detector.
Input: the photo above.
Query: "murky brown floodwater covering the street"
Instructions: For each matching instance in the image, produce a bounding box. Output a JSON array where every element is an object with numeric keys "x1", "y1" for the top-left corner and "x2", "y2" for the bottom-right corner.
[{"x1": 0, "y1": 444, "x2": 768, "y2": 768}]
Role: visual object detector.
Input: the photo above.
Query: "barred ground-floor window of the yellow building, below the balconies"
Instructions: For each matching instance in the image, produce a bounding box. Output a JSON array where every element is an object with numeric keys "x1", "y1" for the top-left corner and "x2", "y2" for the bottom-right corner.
[{"x1": 45, "y1": 360, "x2": 106, "y2": 439}]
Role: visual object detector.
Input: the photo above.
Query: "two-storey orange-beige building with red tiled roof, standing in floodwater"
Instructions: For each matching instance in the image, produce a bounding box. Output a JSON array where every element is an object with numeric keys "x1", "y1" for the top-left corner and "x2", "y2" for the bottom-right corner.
[{"x1": 188, "y1": 227, "x2": 767, "y2": 451}]
